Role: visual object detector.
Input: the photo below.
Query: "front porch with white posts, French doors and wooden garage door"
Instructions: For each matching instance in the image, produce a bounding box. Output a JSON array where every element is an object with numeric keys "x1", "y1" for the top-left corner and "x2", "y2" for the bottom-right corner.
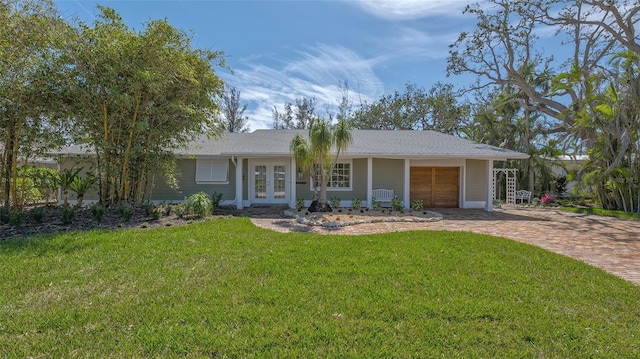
[{"x1": 232, "y1": 157, "x2": 502, "y2": 211}]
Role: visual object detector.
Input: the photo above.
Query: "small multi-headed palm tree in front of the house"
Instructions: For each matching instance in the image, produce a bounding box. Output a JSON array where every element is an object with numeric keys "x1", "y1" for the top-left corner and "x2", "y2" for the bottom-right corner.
[{"x1": 289, "y1": 118, "x2": 353, "y2": 212}]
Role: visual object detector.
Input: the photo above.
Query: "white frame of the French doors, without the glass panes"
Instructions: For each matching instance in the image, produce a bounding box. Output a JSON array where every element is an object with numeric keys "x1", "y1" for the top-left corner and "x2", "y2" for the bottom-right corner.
[{"x1": 248, "y1": 158, "x2": 291, "y2": 204}]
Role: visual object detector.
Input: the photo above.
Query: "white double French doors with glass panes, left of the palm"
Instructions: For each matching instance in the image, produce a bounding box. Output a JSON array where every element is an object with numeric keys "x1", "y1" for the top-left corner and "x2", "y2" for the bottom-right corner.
[{"x1": 249, "y1": 161, "x2": 290, "y2": 204}]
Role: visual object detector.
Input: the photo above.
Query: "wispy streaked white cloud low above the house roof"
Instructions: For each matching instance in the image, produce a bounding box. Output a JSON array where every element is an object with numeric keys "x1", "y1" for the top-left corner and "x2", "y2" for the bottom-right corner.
[{"x1": 223, "y1": 44, "x2": 384, "y2": 130}]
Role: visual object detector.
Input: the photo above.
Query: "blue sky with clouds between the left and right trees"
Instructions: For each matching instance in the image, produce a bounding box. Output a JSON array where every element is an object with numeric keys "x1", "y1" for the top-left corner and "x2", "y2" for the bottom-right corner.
[{"x1": 56, "y1": 0, "x2": 475, "y2": 130}]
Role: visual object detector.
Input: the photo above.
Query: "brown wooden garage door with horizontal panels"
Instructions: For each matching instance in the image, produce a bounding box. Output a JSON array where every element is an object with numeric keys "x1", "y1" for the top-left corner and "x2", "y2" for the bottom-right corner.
[{"x1": 409, "y1": 167, "x2": 460, "y2": 208}]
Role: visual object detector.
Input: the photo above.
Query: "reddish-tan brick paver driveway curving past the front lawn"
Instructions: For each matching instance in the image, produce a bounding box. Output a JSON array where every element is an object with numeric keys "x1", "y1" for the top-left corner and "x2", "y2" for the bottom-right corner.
[{"x1": 252, "y1": 208, "x2": 640, "y2": 285}]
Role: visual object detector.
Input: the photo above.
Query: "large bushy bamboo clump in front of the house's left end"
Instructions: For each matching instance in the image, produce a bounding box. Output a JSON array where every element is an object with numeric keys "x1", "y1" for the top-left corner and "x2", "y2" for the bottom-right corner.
[{"x1": 69, "y1": 6, "x2": 224, "y2": 204}]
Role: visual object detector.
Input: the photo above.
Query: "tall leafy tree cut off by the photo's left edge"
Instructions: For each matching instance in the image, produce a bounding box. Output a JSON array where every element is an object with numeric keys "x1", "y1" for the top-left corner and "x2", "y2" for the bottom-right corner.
[{"x1": 0, "y1": 0, "x2": 67, "y2": 208}]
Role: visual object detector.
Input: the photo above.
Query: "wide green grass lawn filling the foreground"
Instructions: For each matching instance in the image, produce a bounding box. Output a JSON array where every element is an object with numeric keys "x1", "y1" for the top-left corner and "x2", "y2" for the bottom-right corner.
[{"x1": 0, "y1": 218, "x2": 640, "y2": 358}]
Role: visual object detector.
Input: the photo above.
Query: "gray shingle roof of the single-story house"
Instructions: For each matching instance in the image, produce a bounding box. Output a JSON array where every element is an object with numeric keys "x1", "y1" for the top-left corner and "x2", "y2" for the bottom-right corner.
[{"x1": 176, "y1": 130, "x2": 529, "y2": 160}]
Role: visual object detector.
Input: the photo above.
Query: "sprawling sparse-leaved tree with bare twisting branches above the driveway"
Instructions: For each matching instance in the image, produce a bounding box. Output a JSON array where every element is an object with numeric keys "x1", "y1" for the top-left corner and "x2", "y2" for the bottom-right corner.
[{"x1": 447, "y1": 0, "x2": 640, "y2": 133}]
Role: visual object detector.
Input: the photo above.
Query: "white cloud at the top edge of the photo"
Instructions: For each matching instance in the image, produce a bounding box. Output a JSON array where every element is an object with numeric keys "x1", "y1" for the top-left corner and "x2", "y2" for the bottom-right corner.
[{"x1": 355, "y1": 0, "x2": 471, "y2": 20}]
